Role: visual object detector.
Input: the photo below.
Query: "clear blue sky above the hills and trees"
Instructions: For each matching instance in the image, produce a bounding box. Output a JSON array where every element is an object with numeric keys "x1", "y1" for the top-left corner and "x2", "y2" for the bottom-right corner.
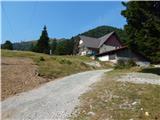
[{"x1": 1, "y1": 1, "x2": 126, "y2": 42}]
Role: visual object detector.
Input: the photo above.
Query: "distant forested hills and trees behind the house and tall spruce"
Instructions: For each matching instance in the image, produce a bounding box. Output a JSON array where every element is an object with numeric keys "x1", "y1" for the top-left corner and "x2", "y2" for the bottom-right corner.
[{"x1": 13, "y1": 26, "x2": 128, "y2": 55}]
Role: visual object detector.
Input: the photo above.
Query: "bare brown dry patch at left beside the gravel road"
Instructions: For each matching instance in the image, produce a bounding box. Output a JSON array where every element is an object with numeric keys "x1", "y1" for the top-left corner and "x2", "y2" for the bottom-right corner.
[{"x1": 1, "y1": 57, "x2": 49, "y2": 100}]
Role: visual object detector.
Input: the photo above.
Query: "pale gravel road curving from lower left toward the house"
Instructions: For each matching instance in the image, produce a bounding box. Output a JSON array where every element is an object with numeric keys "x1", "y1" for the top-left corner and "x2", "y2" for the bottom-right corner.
[{"x1": 2, "y1": 69, "x2": 111, "y2": 120}]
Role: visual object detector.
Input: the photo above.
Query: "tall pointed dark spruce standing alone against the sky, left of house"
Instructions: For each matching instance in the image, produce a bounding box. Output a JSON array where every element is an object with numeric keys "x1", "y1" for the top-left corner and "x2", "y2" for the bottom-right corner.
[{"x1": 36, "y1": 26, "x2": 50, "y2": 54}]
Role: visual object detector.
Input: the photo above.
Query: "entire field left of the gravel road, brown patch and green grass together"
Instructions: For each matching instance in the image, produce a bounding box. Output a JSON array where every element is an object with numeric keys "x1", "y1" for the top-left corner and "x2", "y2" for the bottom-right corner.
[{"x1": 1, "y1": 50, "x2": 111, "y2": 100}]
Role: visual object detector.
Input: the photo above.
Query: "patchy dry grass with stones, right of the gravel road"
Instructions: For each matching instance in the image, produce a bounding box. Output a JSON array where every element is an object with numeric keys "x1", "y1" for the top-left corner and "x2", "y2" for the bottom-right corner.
[{"x1": 71, "y1": 68, "x2": 160, "y2": 120}]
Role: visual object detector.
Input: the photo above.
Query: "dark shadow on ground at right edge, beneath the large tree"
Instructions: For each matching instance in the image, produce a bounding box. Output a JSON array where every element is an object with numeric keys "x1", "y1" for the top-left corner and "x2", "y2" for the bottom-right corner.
[{"x1": 140, "y1": 68, "x2": 160, "y2": 75}]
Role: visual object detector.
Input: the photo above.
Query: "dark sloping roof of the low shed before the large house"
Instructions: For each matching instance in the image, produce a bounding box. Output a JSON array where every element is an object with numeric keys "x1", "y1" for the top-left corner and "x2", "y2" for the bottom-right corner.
[{"x1": 96, "y1": 46, "x2": 128, "y2": 57}]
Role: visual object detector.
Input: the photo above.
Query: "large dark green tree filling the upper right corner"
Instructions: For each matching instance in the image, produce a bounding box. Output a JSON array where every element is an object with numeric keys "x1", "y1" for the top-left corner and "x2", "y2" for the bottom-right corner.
[{"x1": 121, "y1": 1, "x2": 160, "y2": 63}]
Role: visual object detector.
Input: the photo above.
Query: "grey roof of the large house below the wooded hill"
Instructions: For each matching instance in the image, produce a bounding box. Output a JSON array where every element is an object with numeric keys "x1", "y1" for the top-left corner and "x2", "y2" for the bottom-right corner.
[{"x1": 80, "y1": 32, "x2": 115, "y2": 48}]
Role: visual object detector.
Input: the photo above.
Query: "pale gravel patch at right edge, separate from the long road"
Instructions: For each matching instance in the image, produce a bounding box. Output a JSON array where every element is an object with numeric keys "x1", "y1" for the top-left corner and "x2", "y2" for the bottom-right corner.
[{"x1": 118, "y1": 73, "x2": 160, "y2": 85}]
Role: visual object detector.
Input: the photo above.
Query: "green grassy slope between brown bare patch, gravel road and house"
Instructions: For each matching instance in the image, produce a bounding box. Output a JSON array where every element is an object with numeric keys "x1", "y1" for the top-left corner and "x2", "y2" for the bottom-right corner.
[{"x1": 1, "y1": 50, "x2": 111, "y2": 78}]
